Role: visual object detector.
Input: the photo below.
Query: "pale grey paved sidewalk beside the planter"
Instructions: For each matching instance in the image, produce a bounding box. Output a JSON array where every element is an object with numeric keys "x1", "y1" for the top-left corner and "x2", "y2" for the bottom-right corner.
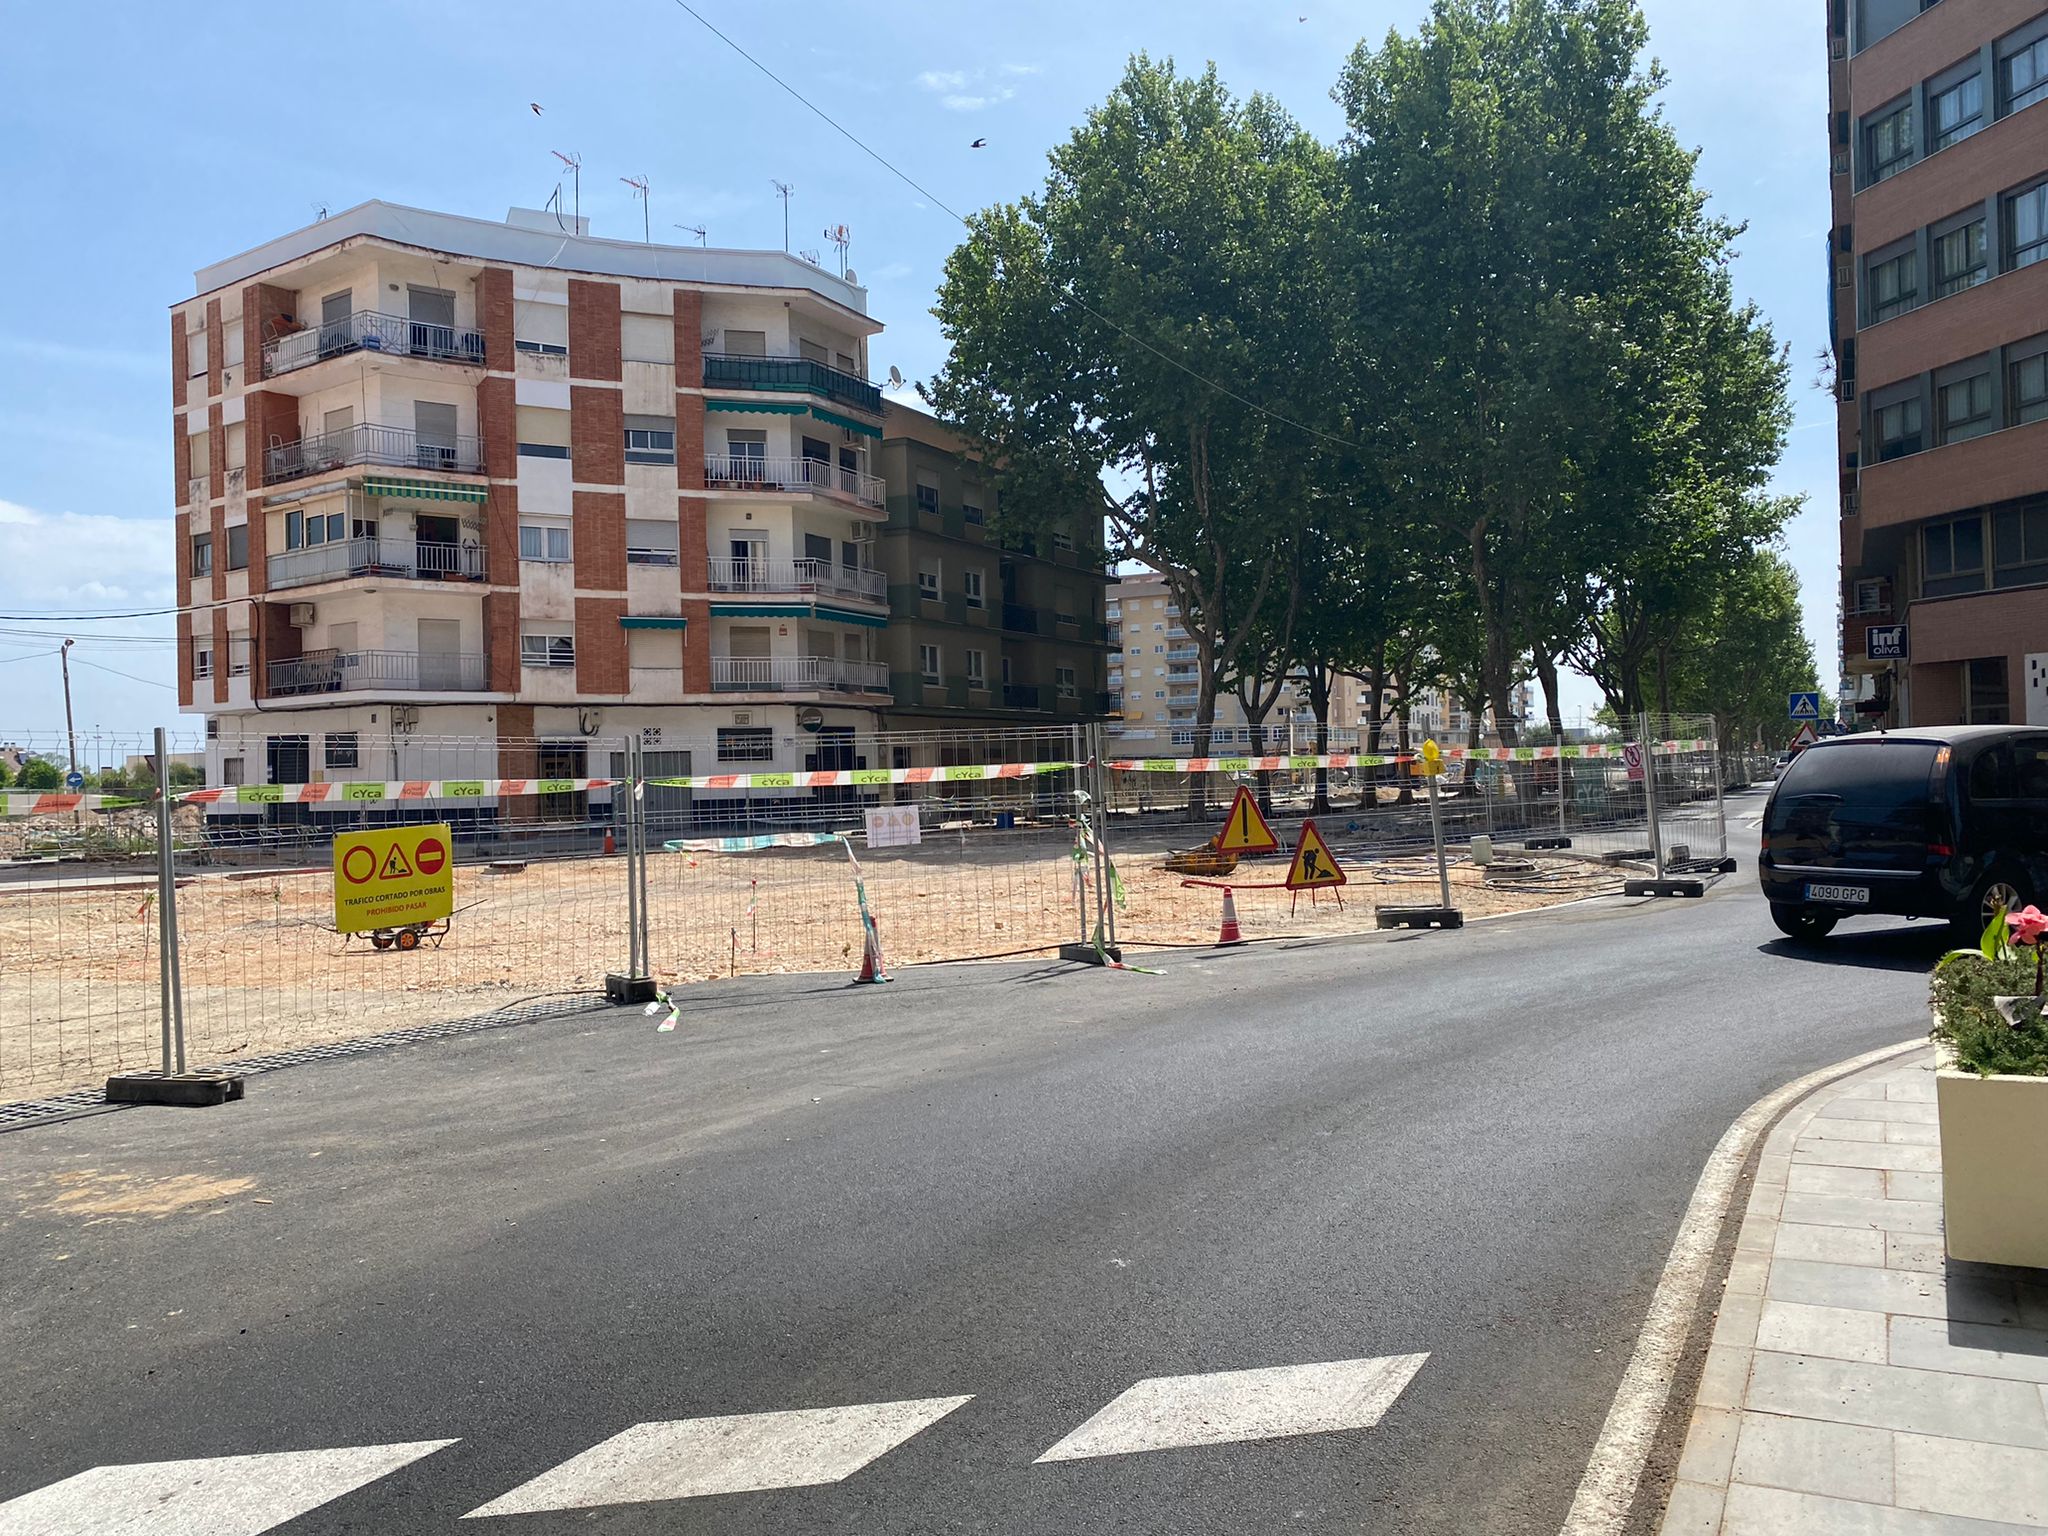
[{"x1": 1663, "y1": 1051, "x2": 2048, "y2": 1536}]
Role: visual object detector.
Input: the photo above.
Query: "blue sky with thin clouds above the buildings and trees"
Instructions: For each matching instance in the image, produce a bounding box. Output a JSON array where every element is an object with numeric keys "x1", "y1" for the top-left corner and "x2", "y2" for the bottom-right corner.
[{"x1": 0, "y1": 0, "x2": 1835, "y2": 741}]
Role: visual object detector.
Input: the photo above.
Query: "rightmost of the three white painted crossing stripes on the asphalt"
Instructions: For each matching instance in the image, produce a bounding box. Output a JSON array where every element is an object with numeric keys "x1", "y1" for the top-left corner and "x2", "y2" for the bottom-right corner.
[{"x1": 1038, "y1": 1354, "x2": 1430, "y2": 1462}]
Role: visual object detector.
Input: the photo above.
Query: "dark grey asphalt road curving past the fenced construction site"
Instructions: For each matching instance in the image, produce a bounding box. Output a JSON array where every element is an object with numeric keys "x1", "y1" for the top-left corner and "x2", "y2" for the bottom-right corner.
[{"x1": 0, "y1": 801, "x2": 1944, "y2": 1536}]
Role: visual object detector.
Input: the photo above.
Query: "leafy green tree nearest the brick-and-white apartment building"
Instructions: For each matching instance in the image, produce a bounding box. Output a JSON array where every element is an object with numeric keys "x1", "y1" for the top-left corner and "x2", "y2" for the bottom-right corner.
[{"x1": 926, "y1": 55, "x2": 1337, "y2": 770}]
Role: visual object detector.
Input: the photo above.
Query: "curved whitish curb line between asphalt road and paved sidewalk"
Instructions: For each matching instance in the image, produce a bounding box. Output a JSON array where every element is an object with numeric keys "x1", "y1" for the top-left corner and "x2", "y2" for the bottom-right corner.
[{"x1": 1559, "y1": 1038, "x2": 1927, "y2": 1536}]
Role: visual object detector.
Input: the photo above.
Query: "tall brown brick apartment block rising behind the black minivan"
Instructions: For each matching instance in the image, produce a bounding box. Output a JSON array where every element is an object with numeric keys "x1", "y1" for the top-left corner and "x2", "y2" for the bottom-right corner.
[{"x1": 1827, "y1": 0, "x2": 2048, "y2": 725}]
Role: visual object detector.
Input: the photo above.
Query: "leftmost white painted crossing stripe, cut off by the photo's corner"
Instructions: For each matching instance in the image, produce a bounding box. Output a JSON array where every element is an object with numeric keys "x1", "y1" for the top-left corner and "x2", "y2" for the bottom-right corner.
[{"x1": 0, "y1": 1440, "x2": 455, "y2": 1536}]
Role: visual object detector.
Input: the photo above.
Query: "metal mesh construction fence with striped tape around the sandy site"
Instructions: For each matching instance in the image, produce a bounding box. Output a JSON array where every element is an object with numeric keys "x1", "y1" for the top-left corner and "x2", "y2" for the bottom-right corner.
[{"x1": 0, "y1": 721, "x2": 1726, "y2": 1100}]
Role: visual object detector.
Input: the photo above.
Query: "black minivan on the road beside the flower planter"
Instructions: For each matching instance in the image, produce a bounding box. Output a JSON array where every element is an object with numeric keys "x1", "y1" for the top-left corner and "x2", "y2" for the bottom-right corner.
[{"x1": 1757, "y1": 725, "x2": 2048, "y2": 942}]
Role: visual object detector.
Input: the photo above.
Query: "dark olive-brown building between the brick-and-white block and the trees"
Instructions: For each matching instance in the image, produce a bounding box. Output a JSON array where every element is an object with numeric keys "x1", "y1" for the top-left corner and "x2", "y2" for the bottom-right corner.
[{"x1": 874, "y1": 399, "x2": 1110, "y2": 731}]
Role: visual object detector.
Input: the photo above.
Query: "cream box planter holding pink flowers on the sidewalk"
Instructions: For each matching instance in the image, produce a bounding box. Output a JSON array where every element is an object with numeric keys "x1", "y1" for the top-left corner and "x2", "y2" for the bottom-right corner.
[{"x1": 1933, "y1": 1061, "x2": 2048, "y2": 1270}]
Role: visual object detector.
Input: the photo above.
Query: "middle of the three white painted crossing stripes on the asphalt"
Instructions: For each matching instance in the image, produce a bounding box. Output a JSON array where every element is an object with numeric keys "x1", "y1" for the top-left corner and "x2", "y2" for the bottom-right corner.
[{"x1": 463, "y1": 1397, "x2": 973, "y2": 1520}]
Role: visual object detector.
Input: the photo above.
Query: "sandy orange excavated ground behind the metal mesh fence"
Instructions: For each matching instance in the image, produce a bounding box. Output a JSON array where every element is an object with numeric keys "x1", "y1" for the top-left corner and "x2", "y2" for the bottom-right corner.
[{"x1": 0, "y1": 827, "x2": 1616, "y2": 1100}]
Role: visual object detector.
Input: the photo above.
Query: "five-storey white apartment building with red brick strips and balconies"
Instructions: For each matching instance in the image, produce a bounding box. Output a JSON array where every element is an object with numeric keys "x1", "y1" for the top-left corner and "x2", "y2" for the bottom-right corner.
[{"x1": 170, "y1": 203, "x2": 895, "y2": 819}]
